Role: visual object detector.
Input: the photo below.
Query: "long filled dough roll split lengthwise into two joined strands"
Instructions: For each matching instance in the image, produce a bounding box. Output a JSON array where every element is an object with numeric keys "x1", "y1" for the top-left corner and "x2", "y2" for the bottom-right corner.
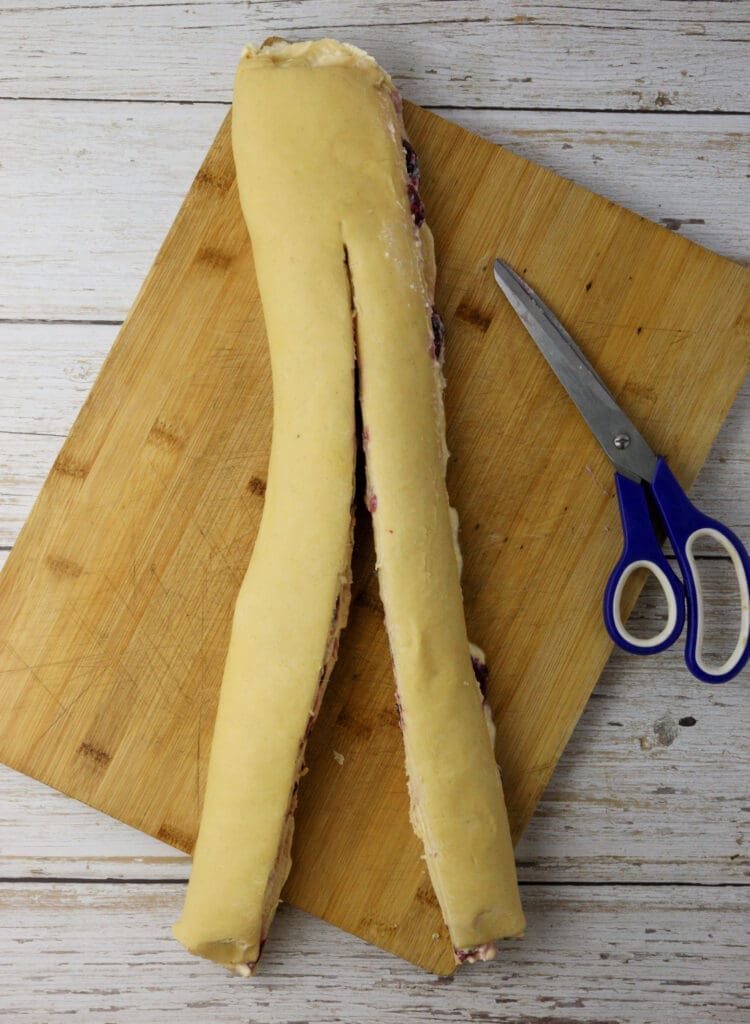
[{"x1": 174, "y1": 40, "x2": 524, "y2": 974}]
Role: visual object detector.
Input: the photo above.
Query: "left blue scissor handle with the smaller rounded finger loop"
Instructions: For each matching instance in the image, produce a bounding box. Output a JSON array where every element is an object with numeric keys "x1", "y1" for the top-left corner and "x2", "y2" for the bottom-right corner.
[{"x1": 605, "y1": 473, "x2": 685, "y2": 654}]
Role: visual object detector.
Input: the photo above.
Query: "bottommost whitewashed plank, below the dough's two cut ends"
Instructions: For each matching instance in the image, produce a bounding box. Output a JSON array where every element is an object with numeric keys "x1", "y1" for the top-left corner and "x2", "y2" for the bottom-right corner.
[{"x1": 0, "y1": 884, "x2": 750, "y2": 1024}]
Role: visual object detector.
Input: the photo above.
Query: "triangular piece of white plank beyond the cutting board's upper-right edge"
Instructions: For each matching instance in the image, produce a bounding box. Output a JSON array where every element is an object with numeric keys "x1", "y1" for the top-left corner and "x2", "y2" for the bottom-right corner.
[{"x1": 442, "y1": 110, "x2": 750, "y2": 263}]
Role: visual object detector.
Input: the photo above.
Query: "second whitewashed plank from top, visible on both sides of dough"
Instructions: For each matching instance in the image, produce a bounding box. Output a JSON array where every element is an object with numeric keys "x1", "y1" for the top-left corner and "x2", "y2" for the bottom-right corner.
[{"x1": 0, "y1": 101, "x2": 750, "y2": 319}]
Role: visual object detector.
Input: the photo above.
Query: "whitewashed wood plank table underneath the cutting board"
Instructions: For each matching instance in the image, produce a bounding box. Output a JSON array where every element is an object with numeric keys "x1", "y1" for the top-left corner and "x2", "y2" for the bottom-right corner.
[{"x1": 0, "y1": 0, "x2": 750, "y2": 1024}]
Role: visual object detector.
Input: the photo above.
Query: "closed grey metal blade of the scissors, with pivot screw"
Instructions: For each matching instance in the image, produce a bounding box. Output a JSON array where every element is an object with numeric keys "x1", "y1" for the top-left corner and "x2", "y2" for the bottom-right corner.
[{"x1": 495, "y1": 253, "x2": 657, "y2": 482}]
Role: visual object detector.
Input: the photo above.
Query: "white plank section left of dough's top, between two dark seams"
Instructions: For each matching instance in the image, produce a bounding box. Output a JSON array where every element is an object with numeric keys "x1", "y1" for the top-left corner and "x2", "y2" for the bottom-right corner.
[{"x1": 0, "y1": 102, "x2": 225, "y2": 321}]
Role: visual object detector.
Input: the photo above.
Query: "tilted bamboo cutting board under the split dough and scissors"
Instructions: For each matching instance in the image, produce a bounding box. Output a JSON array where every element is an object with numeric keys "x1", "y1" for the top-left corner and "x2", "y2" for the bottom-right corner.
[{"x1": 0, "y1": 106, "x2": 750, "y2": 974}]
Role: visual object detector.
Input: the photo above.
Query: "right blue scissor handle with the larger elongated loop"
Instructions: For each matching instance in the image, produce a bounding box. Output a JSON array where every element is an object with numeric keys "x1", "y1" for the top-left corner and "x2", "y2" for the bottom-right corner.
[{"x1": 651, "y1": 459, "x2": 750, "y2": 683}]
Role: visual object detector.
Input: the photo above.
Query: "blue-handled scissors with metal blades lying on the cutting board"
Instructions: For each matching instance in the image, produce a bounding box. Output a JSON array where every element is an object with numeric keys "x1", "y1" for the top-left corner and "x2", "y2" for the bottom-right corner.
[{"x1": 495, "y1": 259, "x2": 750, "y2": 683}]
